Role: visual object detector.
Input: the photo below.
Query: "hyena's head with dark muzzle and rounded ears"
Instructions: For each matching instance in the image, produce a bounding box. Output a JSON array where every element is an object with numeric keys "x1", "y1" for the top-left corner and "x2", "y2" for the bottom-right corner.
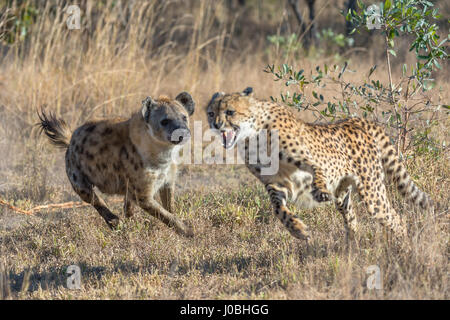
[{"x1": 142, "y1": 92, "x2": 195, "y2": 144}]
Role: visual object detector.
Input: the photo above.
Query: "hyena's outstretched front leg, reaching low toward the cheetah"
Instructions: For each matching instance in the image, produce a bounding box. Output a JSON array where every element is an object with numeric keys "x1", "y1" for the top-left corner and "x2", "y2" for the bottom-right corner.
[{"x1": 137, "y1": 196, "x2": 194, "y2": 237}]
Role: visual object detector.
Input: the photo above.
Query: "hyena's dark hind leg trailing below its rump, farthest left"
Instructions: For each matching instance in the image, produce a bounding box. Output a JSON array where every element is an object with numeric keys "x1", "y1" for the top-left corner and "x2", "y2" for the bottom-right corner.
[{"x1": 68, "y1": 170, "x2": 119, "y2": 229}]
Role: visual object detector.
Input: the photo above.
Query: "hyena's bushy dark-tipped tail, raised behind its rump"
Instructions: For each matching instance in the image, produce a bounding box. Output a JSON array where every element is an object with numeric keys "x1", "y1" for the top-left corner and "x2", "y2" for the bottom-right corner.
[{"x1": 37, "y1": 109, "x2": 72, "y2": 148}]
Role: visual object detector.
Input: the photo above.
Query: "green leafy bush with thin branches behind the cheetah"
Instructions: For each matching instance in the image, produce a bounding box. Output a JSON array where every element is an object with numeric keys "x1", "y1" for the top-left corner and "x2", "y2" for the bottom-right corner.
[{"x1": 265, "y1": 0, "x2": 450, "y2": 153}]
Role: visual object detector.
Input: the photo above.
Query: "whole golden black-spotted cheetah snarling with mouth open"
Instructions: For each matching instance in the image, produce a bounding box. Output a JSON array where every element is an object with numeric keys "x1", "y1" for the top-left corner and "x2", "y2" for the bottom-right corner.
[{"x1": 206, "y1": 87, "x2": 433, "y2": 240}]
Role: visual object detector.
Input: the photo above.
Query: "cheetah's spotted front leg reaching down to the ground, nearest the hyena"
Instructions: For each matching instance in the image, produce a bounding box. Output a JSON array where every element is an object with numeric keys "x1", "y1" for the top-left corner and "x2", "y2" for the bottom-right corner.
[{"x1": 266, "y1": 184, "x2": 310, "y2": 240}]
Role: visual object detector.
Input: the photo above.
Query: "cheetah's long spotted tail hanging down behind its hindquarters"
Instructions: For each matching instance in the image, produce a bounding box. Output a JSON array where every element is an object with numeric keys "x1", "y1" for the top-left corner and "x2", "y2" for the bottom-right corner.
[{"x1": 375, "y1": 127, "x2": 436, "y2": 210}]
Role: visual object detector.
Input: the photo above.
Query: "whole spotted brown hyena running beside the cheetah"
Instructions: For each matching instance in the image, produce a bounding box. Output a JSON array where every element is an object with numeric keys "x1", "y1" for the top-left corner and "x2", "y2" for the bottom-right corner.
[{"x1": 38, "y1": 92, "x2": 195, "y2": 236}]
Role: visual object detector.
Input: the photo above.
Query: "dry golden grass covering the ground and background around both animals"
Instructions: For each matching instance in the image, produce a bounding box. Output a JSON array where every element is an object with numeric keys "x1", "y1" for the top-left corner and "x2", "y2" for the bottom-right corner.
[{"x1": 0, "y1": 0, "x2": 450, "y2": 299}]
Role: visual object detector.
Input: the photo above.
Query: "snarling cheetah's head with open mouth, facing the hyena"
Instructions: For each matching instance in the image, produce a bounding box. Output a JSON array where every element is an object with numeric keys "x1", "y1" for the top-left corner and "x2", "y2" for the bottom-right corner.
[{"x1": 206, "y1": 87, "x2": 254, "y2": 149}]
